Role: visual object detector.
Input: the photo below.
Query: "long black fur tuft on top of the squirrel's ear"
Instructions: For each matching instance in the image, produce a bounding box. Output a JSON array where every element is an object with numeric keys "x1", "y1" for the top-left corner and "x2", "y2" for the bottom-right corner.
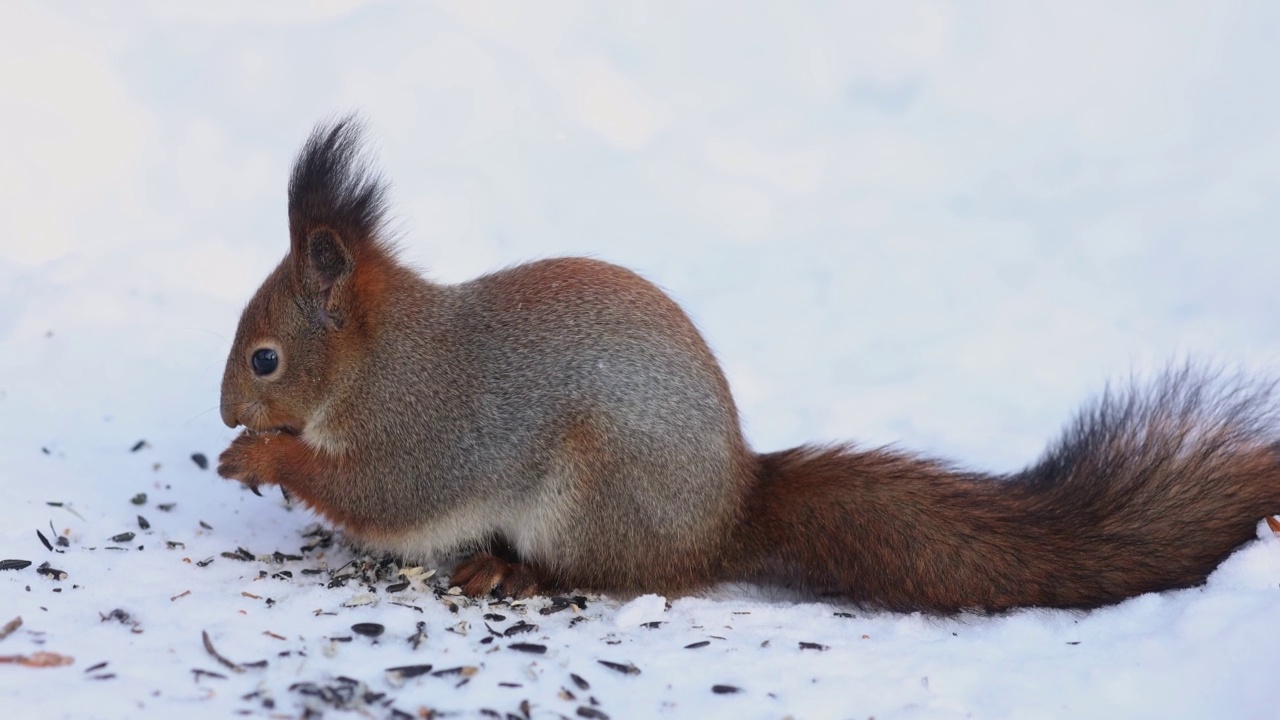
[{"x1": 289, "y1": 115, "x2": 387, "y2": 261}]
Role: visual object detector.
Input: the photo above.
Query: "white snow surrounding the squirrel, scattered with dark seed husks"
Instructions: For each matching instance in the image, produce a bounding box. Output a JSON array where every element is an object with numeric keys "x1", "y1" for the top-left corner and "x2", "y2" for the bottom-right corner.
[{"x1": 0, "y1": 1, "x2": 1280, "y2": 719}]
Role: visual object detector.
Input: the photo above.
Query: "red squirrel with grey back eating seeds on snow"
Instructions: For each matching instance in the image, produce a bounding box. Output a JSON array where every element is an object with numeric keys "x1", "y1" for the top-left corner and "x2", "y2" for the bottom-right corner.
[{"x1": 218, "y1": 117, "x2": 1280, "y2": 614}]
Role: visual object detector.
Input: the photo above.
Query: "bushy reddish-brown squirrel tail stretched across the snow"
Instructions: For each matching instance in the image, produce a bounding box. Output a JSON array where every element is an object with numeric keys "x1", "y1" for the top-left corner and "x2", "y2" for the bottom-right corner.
[{"x1": 731, "y1": 368, "x2": 1280, "y2": 612}]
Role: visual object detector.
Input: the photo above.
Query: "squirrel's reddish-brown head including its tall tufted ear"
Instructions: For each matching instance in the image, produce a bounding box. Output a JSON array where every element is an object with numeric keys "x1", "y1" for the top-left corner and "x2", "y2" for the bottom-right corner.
[{"x1": 221, "y1": 117, "x2": 393, "y2": 433}]
